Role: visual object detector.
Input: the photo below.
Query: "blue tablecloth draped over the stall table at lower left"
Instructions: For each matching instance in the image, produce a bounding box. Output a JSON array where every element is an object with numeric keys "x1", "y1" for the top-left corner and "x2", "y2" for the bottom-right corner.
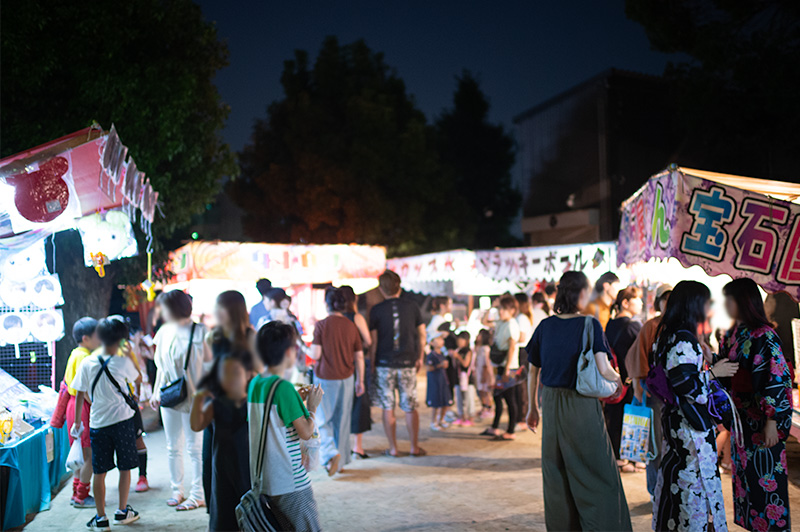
[{"x1": 0, "y1": 424, "x2": 69, "y2": 530}]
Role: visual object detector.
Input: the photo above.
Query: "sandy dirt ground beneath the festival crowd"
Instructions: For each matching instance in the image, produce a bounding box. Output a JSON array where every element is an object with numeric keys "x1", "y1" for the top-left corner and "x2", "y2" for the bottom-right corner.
[{"x1": 21, "y1": 381, "x2": 800, "y2": 532}]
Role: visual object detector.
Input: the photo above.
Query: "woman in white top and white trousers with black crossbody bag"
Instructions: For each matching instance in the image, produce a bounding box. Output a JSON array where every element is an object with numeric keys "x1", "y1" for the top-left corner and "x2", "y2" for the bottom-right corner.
[{"x1": 150, "y1": 290, "x2": 212, "y2": 510}]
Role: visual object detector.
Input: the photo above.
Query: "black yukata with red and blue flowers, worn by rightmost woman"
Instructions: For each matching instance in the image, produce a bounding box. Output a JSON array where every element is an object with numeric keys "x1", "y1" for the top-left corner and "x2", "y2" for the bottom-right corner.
[{"x1": 720, "y1": 325, "x2": 792, "y2": 531}]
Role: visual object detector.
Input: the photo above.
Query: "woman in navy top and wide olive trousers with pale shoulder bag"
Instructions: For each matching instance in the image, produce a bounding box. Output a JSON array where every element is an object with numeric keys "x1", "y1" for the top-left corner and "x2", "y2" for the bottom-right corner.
[{"x1": 526, "y1": 272, "x2": 631, "y2": 530}]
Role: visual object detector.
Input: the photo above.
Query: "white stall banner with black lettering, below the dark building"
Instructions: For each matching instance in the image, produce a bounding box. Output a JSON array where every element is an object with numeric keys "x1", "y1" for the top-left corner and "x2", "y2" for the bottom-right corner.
[{"x1": 475, "y1": 242, "x2": 617, "y2": 282}]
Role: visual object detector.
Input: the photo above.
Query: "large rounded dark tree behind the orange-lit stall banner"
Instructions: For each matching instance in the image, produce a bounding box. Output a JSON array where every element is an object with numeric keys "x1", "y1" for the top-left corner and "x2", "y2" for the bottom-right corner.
[{"x1": 229, "y1": 37, "x2": 458, "y2": 254}]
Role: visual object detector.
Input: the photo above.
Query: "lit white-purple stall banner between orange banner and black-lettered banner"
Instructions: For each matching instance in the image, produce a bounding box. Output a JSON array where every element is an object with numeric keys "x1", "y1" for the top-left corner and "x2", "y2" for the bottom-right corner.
[{"x1": 386, "y1": 249, "x2": 514, "y2": 297}]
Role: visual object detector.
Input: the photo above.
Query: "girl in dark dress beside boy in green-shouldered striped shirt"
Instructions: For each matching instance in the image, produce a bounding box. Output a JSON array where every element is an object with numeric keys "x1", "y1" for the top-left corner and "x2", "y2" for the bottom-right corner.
[{"x1": 190, "y1": 352, "x2": 252, "y2": 532}]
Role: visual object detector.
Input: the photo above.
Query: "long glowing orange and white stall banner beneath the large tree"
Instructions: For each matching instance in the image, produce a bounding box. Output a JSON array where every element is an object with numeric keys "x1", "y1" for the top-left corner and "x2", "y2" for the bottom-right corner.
[{"x1": 170, "y1": 241, "x2": 386, "y2": 286}]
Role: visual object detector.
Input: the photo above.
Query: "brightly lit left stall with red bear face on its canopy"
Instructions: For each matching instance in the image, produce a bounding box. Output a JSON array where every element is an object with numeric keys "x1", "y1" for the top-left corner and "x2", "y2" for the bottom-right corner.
[{"x1": 0, "y1": 125, "x2": 158, "y2": 387}]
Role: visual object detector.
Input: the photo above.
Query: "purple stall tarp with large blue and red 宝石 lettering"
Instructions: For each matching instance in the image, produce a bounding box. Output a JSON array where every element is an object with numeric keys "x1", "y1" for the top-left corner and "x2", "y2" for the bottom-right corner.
[{"x1": 617, "y1": 168, "x2": 800, "y2": 299}]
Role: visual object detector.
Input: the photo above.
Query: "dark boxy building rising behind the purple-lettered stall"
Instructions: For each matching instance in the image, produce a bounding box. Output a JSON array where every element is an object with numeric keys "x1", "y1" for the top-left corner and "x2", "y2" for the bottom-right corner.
[{"x1": 514, "y1": 69, "x2": 678, "y2": 246}]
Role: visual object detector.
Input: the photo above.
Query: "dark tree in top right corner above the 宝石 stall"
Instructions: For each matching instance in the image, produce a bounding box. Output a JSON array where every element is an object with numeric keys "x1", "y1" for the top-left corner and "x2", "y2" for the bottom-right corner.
[{"x1": 626, "y1": 0, "x2": 800, "y2": 181}]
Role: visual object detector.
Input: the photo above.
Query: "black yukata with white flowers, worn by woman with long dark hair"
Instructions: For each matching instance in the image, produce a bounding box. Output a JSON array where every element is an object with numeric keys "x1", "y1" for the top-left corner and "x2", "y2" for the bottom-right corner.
[{"x1": 653, "y1": 331, "x2": 727, "y2": 531}]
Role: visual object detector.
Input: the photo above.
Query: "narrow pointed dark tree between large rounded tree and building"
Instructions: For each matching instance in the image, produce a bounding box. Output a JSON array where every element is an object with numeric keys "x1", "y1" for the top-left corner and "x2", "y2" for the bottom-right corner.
[{"x1": 436, "y1": 72, "x2": 522, "y2": 248}]
